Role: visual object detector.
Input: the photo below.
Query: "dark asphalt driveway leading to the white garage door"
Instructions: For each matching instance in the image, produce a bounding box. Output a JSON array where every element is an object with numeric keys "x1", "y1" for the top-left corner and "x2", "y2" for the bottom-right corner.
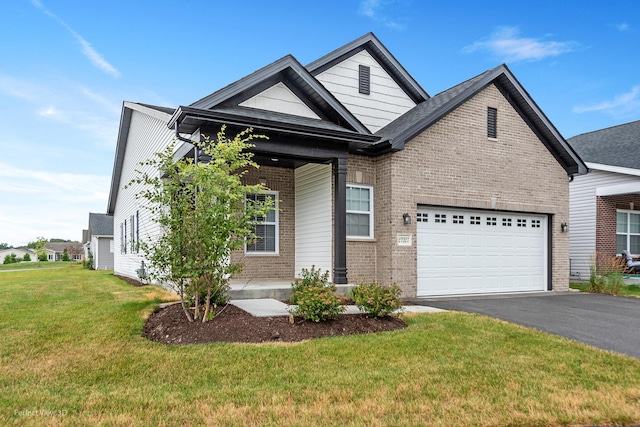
[{"x1": 410, "y1": 292, "x2": 640, "y2": 359}]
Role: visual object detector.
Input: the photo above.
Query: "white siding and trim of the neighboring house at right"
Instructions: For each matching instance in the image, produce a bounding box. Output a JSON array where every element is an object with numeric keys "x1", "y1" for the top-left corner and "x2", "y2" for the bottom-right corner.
[{"x1": 569, "y1": 169, "x2": 640, "y2": 279}]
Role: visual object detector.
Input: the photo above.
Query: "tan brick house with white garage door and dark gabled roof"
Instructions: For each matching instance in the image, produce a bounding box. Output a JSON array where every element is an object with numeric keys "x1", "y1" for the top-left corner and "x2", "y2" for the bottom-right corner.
[{"x1": 107, "y1": 33, "x2": 587, "y2": 297}]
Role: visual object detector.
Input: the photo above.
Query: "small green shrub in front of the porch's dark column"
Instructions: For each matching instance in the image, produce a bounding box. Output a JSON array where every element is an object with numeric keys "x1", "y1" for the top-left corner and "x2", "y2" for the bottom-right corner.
[{"x1": 290, "y1": 284, "x2": 346, "y2": 322}]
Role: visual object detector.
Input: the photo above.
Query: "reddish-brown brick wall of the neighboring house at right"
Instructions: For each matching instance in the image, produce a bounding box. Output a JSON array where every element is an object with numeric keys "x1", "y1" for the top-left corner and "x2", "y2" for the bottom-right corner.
[{"x1": 596, "y1": 194, "x2": 640, "y2": 257}]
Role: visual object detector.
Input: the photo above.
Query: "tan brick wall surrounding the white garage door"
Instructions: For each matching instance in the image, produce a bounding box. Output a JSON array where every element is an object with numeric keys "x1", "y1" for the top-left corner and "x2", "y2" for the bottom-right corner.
[{"x1": 376, "y1": 85, "x2": 569, "y2": 297}]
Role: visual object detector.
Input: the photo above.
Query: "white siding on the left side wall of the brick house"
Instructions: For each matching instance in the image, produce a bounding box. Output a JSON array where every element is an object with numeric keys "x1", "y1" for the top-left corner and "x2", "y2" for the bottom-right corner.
[{"x1": 113, "y1": 110, "x2": 174, "y2": 278}]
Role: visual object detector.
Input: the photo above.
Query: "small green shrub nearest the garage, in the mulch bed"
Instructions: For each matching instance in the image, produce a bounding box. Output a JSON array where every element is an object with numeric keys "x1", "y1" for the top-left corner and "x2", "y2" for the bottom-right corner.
[{"x1": 351, "y1": 282, "x2": 402, "y2": 319}]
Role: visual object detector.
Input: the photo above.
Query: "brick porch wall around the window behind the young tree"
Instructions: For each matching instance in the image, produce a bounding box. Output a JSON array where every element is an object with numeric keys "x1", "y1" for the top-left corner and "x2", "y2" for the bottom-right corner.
[{"x1": 231, "y1": 166, "x2": 295, "y2": 280}]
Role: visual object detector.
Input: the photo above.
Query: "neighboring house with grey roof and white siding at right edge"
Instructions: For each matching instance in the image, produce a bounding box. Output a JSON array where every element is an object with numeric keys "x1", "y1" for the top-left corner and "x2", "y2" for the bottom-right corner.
[{"x1": 568, "y1": 121, "x2": 640, "y2": 279}]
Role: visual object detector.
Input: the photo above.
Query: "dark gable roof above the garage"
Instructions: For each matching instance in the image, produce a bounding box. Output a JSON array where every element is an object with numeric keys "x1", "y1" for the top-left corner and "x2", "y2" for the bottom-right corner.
[{"x1": 376, "y1": 64, "x2": 587, "y2": 174}]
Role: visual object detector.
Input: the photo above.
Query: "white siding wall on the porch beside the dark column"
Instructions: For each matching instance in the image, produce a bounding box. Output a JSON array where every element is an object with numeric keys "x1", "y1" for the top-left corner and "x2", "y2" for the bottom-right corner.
[{"x1": 295, "y1": 164, "x2": 333, "y2": 278}]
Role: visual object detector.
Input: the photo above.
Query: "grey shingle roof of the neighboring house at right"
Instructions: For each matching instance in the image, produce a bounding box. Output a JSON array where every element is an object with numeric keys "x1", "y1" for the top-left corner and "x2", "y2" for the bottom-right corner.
[{"x1": 567, "y1": 120, "x2": 640, "y2": 169}]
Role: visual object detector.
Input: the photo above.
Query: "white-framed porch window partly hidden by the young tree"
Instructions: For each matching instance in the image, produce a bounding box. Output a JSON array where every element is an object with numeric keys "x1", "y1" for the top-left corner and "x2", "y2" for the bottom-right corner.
[{"x1": 245, "y1": 191, "x2": 279, "y2": 255}]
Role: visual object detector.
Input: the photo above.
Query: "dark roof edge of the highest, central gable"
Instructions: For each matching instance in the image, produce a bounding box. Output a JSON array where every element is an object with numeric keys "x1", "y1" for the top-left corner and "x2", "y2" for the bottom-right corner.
[{"x1": 307, "y1": 33, "x2": 429, "y2": 104}]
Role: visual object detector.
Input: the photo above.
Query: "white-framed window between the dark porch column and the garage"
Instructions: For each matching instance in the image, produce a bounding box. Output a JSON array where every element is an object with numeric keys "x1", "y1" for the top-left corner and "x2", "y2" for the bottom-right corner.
[{"x1": 347, "y1": 184, "x2": 373, "y2": 239}]
